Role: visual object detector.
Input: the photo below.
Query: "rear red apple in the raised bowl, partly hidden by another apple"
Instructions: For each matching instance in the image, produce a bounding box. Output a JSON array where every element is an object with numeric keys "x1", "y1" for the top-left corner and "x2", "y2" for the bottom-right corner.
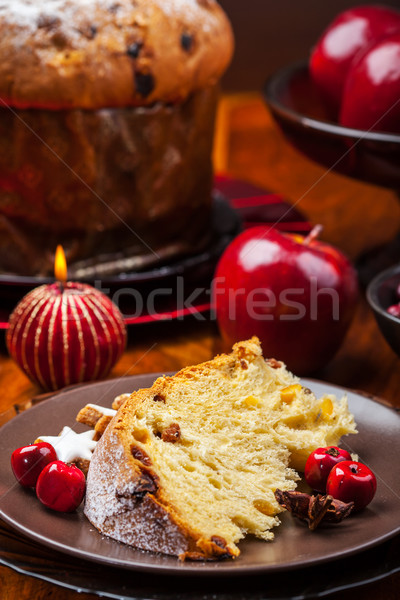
[{"x1": 310, "y1": 5, "x2": 400, "y2": 110}]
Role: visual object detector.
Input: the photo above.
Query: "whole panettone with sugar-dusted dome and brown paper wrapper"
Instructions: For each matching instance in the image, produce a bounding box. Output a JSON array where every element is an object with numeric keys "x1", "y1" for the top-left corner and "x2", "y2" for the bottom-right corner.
[{"x1": 0, "y1": 0, "x2": 233, "y2": 275}]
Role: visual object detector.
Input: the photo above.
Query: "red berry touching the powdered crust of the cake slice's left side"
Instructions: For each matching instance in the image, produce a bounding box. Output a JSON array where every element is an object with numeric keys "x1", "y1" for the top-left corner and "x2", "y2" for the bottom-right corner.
[{"x1": 36, "y1": 460, "x2": 86, "y2": 512}]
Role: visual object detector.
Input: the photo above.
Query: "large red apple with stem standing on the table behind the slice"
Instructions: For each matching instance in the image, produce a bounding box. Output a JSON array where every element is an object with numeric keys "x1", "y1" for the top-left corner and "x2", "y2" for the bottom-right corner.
[{"x1": 213, "y1": 226, "x2": 358, "y2": 375}]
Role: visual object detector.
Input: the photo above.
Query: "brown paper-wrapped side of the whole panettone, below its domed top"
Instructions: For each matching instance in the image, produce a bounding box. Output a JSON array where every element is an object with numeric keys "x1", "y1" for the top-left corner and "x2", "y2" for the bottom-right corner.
[{"x1": 0, "y1": 86, "x2": 218, "y2": 279}]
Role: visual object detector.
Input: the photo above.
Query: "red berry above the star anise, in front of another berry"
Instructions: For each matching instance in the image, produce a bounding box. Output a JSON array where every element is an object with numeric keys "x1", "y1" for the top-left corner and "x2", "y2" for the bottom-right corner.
[{"x1": 326, "y1": 460, "x2": 376, "y2": 510}]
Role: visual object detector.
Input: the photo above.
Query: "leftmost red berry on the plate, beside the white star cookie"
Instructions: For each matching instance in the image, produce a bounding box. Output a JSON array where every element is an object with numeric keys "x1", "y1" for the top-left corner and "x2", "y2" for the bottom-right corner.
[{"x1": 11, "y1": 442, "x2": 57, "y2": 487}]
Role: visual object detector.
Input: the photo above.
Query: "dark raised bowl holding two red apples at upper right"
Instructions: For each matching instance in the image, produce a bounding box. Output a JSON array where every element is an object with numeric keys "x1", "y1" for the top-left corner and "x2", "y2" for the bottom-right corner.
[{"x1": 264, "y1": 61, "x2": 400, "y2": 190}]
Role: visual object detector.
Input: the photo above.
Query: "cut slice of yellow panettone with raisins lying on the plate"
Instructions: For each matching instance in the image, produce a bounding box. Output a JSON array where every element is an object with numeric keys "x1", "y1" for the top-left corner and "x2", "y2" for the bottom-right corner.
[{"x1": 85, "y1": 338, "x2": 356, "y2": 559}]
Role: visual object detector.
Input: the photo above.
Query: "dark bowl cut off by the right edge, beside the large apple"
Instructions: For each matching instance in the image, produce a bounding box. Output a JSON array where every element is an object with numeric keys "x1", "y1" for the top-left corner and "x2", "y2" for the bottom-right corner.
[{"x1": 367, "y1": 265, "x2": 400, "y2": 356}]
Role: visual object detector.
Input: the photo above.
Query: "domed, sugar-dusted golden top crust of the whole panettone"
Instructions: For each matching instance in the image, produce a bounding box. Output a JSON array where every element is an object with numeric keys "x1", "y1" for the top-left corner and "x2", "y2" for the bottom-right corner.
[{"x1": 0, "y1": 0, "x2": 233, "y2": 110}]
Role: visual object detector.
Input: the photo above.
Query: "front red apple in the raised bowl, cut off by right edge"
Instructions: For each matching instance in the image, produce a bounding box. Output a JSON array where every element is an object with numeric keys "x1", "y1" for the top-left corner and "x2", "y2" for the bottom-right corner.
[{"x1": 339, "y1": 30, "x2": 400, "y2": 133}]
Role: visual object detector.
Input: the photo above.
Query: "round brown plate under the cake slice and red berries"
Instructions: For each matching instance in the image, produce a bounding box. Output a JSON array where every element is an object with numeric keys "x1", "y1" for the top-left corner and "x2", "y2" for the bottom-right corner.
[{"x1": 0, "y1": 374, "x2": 400, "y2": 576}]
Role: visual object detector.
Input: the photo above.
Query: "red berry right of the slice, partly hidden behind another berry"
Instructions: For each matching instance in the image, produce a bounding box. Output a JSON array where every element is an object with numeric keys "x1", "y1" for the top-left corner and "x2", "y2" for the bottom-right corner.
[{"x1": 304, "y1": 446, "x2": 351, "y2": 494}]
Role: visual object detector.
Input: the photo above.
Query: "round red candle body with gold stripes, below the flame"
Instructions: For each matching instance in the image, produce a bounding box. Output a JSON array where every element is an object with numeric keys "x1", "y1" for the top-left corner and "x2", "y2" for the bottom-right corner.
[{"x1": 6, "y1": 282, "x2": 126, "y2": 390}]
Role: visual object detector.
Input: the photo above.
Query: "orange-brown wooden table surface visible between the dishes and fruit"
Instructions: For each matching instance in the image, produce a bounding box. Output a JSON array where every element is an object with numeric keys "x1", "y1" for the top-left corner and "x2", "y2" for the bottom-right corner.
[{"x1": 0, "y1": 94, "x2": 400, "y2": 600}]
